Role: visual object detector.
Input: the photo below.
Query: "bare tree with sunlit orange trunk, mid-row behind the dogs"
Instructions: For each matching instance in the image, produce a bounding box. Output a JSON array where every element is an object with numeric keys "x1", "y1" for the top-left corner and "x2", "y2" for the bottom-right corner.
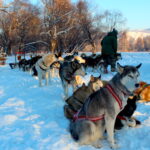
[{"x1": 41, "y1": 0, "x2": 73, "y2": 52}]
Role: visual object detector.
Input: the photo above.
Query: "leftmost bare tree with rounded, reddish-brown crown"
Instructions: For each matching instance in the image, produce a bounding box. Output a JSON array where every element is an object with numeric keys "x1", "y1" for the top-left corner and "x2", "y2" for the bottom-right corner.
[{"x1": 0, "y1": 0, "x2": 40, "y2": 54}]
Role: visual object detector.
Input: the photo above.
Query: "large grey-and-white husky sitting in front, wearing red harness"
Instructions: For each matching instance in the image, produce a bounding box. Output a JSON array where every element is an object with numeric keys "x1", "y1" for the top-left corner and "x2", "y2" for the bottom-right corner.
[{"x1": 70, "y1": 63, "x2": 141, "y2": 148}]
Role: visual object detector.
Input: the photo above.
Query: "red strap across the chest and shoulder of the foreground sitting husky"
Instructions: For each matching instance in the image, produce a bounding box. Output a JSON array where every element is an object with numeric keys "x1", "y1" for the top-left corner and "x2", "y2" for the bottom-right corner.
[{"x1": 106, "y1": 84, "x2": 122, "y2": 110}]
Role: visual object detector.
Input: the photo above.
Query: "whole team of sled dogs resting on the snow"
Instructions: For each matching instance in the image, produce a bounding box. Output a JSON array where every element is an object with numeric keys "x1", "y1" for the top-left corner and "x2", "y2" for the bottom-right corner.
[{"x1": 11, "y1": 52, "x2": 150, "y2": 149}]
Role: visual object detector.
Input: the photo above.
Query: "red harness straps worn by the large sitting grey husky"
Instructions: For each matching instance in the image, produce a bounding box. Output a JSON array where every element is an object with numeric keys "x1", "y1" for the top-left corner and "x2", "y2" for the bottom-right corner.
[{"x1": 73, "y1": 84, "x2": 122, "y2": 122}]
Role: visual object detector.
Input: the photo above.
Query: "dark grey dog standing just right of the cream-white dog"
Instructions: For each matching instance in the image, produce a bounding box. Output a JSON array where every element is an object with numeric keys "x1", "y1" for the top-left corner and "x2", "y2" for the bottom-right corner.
[{"x1": 59, "y1": 60, "x2": 85, "y2": 98}]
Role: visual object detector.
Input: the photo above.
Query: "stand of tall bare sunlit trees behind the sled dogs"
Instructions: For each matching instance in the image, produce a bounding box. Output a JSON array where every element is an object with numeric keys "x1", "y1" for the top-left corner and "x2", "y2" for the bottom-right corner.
[{"x1": 0, "y1": 0, "x2": 129, "y2": 53}]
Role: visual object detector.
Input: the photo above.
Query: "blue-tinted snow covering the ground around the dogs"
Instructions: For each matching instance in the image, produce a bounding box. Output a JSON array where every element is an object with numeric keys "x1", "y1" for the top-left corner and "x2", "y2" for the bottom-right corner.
[{"x1": 0, "y1": 53, "x2": 150, "y2": 150}]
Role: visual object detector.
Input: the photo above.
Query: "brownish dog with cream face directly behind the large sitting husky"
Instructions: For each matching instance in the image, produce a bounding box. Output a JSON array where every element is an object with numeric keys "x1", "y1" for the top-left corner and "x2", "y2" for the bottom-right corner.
[{"x1": 64, "y1": 75, "x2": 103, "y2": 119}]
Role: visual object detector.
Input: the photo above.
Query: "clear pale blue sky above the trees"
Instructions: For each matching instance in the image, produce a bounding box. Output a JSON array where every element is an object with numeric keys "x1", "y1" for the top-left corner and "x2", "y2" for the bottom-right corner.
[{"x1": 72, "y1": 0, "x2": 150, "y2": 30}]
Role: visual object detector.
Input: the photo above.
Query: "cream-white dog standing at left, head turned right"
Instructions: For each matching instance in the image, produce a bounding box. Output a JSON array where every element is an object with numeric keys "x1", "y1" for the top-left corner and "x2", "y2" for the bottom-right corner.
[{"x1": 35, "y1": 53, "x2": 62, "y2": 86}]
